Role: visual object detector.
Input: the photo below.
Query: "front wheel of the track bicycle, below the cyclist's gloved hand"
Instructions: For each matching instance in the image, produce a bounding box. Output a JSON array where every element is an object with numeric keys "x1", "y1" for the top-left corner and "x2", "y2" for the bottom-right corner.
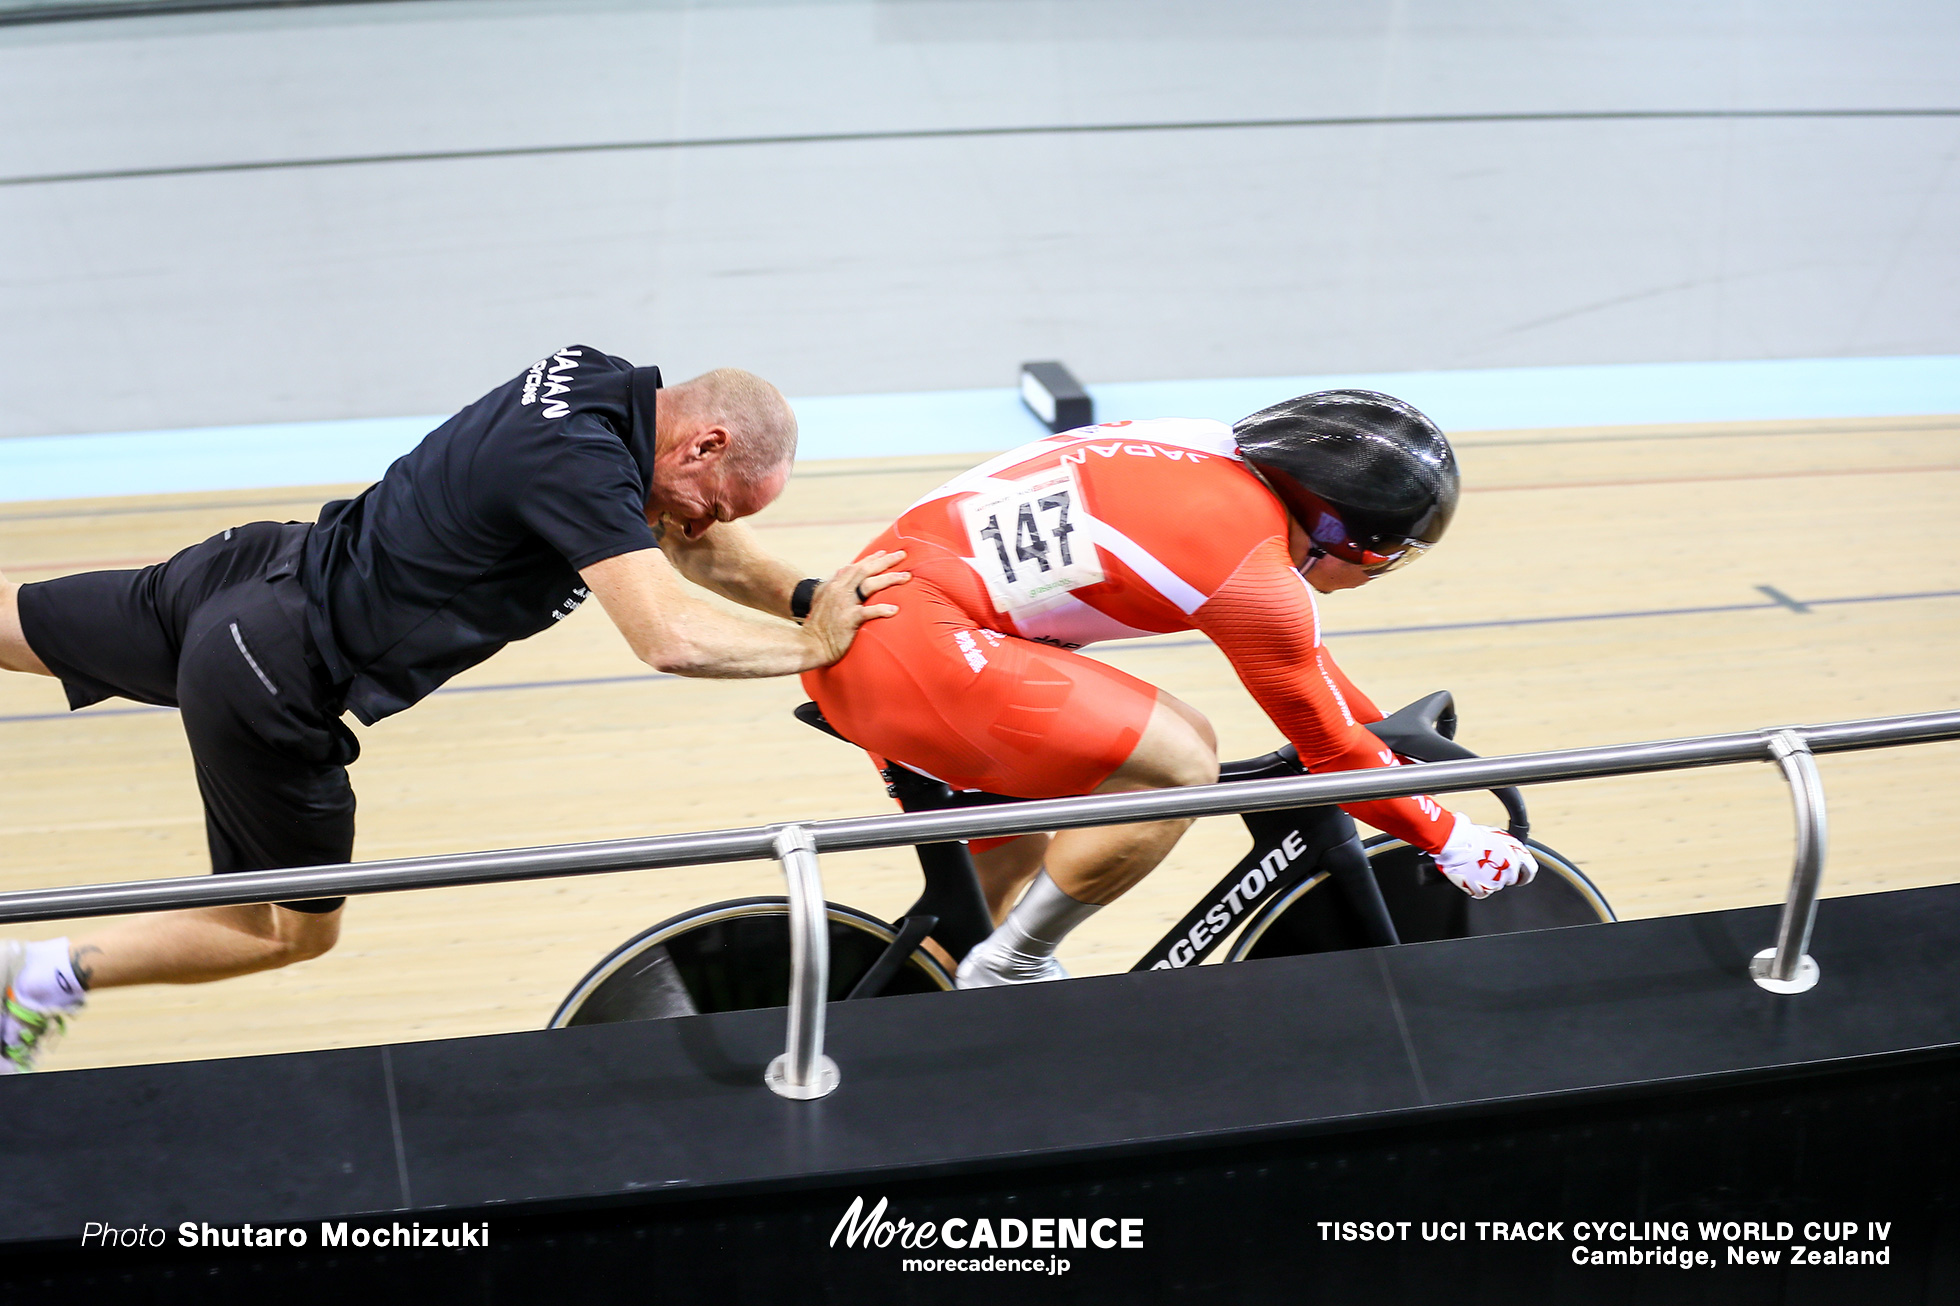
[{"x1": 1225, "y1": 835, "x2": 1615, "y2": 961}]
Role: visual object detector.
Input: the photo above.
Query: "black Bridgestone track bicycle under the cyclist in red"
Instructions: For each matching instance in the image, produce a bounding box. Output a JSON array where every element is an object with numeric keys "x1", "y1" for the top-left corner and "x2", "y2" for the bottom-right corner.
[{"x1": 551, "y1": 692, "x2": 1613, "y2": 1028}]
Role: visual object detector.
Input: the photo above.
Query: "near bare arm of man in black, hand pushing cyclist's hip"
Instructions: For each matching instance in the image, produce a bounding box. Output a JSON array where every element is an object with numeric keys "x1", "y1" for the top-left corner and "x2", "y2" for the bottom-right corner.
[{"x1": 578, "y1": 549, "x2": 909, "y2": 680}]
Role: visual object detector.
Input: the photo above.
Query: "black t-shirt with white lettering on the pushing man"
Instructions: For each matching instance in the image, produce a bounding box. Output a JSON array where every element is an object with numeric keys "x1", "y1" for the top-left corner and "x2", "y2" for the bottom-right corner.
[{"x1": 302, "y1": 345, "x2": 661, "y2": 726}]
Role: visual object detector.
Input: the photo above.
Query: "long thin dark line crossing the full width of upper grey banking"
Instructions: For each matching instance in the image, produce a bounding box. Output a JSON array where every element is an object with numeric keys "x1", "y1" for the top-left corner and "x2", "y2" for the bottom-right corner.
[{"x1": 0, "y1": 108, "x2": 1960, "y2": 186}]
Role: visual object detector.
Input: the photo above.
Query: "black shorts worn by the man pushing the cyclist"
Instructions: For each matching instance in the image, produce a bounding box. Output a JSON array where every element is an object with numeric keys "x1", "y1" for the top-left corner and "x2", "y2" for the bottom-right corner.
[{"x1": 20, "y1": 522, "x2": 361, "y2": 912}]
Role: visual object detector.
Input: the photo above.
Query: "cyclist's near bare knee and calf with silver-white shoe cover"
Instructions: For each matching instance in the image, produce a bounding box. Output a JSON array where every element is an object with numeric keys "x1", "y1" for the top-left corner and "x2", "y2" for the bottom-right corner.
[{"x1": 958, "y1": 692, "x2": 1219, "y2": 988}]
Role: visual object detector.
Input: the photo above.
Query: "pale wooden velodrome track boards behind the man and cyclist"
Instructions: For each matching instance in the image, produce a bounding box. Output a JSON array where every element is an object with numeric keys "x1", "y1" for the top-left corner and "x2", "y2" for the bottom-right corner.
[{"x1": 0, "y1": 418, "x2": 1960, "y2": 1069}]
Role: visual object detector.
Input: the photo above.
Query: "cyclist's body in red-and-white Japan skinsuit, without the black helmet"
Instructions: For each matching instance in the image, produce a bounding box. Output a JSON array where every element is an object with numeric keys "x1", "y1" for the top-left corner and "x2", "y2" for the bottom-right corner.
[{"x1": 804, "y1": 418, "x2": 1523, "y2": 986}]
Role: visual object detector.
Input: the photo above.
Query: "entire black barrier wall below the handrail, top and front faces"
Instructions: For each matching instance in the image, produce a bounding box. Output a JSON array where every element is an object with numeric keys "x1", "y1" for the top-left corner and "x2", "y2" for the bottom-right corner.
[{"x1": 0, "y1": 886, "x2": 1960, "y2": 1306}]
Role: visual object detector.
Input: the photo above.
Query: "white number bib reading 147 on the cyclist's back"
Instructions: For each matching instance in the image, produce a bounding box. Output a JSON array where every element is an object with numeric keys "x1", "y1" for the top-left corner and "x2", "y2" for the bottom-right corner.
[{"x1": 960, "y1": 467, "x2": 1103, "y2": 616}]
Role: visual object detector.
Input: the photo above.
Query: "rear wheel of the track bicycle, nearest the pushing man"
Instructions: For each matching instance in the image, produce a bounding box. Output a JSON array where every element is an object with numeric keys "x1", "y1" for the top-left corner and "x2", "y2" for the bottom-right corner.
[{"x1": 549, "y1": 898, "x2": 953, "y2": 1030}]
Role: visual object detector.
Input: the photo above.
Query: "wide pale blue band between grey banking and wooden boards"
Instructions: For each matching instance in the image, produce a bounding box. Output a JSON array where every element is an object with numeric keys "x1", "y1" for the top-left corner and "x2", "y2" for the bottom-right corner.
[{"x1": 0, "y1": 355, "x2": 1960, "y2": 502}]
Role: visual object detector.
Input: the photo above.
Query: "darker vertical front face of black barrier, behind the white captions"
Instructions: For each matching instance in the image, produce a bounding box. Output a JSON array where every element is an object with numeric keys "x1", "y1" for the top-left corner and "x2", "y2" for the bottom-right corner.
[{"x1": 0, "y1": 1049, "x2": 1960, "y2": 1306}]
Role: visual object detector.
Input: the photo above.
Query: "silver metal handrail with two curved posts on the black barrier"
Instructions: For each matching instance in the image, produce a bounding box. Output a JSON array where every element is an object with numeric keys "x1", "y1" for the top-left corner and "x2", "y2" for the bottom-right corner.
[{"x1": 0, "y1": 712, "x2": 1960, "y2": 1100}]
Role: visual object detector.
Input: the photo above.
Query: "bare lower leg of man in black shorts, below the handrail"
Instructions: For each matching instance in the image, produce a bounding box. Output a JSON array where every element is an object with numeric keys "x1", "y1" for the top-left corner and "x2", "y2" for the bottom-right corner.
[{"x1": 73, "y1": 902, "x2": 345, "y2": 990}]
